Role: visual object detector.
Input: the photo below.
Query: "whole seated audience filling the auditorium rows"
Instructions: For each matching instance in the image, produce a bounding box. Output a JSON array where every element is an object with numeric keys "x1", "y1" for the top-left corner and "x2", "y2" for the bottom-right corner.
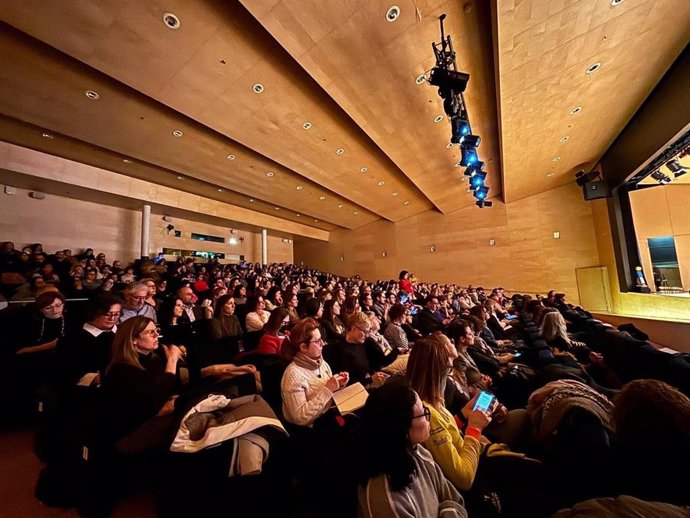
[{"x1": 0, "y1": 243, "x2": 690, "y2": 517}]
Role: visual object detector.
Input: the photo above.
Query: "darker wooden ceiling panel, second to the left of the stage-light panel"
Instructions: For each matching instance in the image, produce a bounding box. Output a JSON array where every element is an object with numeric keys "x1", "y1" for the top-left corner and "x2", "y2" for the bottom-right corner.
[{"x1": 0, "y1": 26, "x2": 370, "y2": 228}]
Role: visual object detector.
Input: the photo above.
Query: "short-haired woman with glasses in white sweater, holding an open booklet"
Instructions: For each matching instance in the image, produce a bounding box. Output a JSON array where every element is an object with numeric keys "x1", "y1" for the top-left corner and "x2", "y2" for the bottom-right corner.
[{"x1": 280, "y1": 318, "x2": 350, "y2": 427}]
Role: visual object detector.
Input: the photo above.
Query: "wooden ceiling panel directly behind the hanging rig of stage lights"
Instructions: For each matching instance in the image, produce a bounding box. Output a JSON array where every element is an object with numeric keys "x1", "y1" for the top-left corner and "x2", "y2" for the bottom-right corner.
[{"x1": 243, "y1": 0, "x2": 500, "y2": 212}]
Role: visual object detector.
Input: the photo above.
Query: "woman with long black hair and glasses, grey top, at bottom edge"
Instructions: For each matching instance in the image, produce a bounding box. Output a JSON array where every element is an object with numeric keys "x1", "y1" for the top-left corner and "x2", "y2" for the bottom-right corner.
[{"x1": 357, "y1": 383, "x2": 467, "y2": 518}]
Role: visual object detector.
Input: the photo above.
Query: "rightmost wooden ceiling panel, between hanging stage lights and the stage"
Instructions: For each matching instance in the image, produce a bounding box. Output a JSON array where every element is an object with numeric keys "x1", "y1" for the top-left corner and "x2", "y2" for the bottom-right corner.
[{"x1": 496, "y1": 0, "x2": 690, "y2": 201}]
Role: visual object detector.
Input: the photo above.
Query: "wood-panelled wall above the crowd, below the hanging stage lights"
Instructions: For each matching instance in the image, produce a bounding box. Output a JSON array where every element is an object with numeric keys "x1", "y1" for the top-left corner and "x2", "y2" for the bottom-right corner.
[{"x1": 294, "y1": 185, "x2": 599, "y2": 301}]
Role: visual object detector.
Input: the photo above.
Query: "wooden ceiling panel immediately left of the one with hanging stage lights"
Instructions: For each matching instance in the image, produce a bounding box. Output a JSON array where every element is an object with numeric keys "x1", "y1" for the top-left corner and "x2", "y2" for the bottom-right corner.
[{"x1": 0, "y1": 0, "x2": 431, "y2": 220}]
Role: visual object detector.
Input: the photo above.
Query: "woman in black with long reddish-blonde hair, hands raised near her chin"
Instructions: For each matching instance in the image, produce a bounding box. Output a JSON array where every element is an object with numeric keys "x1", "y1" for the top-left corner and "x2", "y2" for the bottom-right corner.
[{"x1": 103, "y1": 316, "x2": 184, "y2": 440}]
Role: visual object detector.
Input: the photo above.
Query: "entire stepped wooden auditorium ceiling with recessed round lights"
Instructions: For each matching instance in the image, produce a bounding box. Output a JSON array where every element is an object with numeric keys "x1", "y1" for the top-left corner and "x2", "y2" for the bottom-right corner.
[{"x1": 0, "y1": 0, "x2": 690, "y2": 230}]
